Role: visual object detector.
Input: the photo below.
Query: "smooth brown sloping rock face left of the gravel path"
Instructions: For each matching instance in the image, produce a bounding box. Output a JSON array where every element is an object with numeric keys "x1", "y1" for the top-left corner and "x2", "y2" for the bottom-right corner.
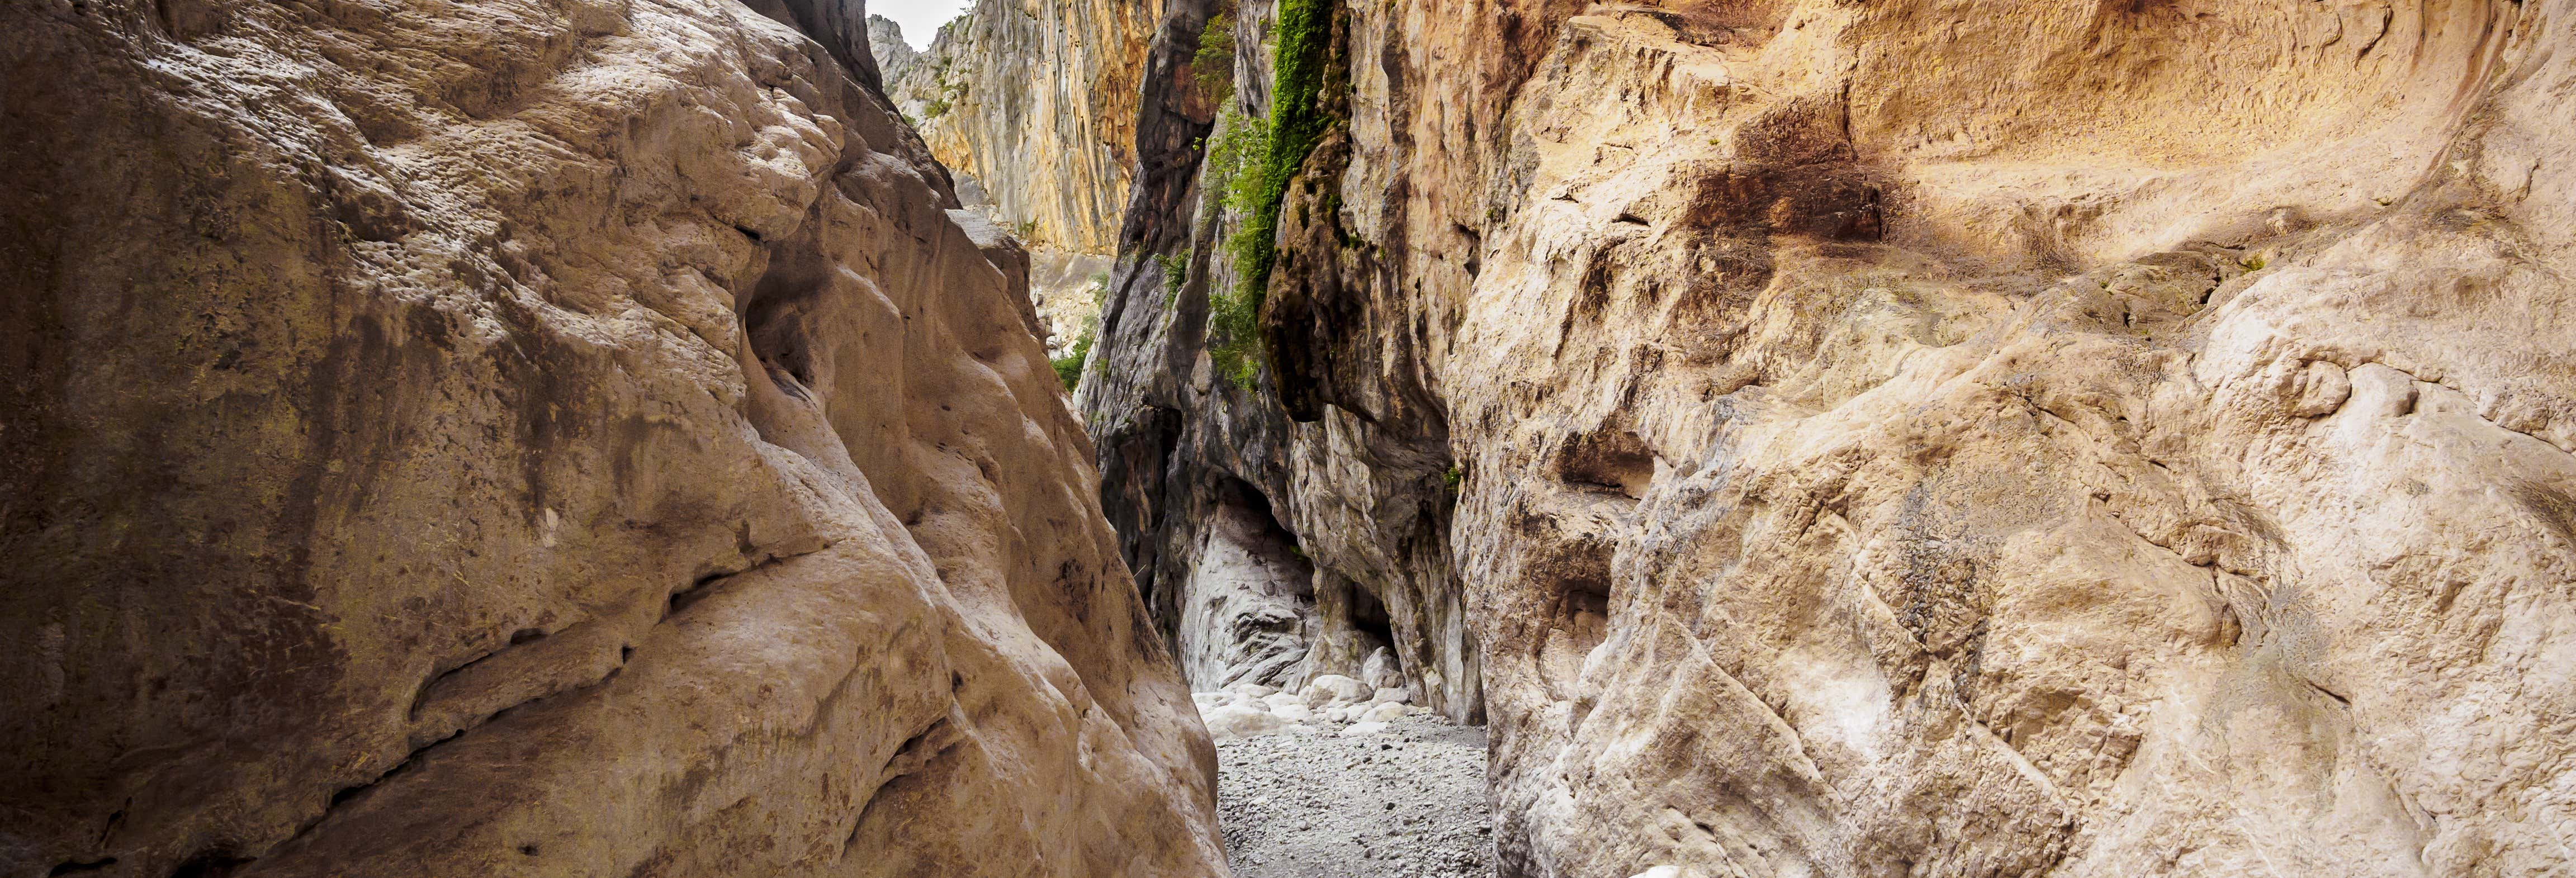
[{"x1": 0, "y1": 0, "x2": 1224, "y2": 878}]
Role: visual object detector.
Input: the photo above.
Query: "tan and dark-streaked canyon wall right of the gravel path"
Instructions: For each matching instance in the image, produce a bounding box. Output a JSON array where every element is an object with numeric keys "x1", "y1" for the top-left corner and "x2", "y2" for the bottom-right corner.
[{"x1": 1082, "y1": 0, "x2": 2576, "y2": 878}]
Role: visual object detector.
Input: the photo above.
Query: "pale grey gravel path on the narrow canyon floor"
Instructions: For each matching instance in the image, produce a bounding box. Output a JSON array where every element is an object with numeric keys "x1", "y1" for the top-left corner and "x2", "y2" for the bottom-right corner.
[{"x1": 1216, "y1": 716, "x2": 1494, "y2": 878}]
